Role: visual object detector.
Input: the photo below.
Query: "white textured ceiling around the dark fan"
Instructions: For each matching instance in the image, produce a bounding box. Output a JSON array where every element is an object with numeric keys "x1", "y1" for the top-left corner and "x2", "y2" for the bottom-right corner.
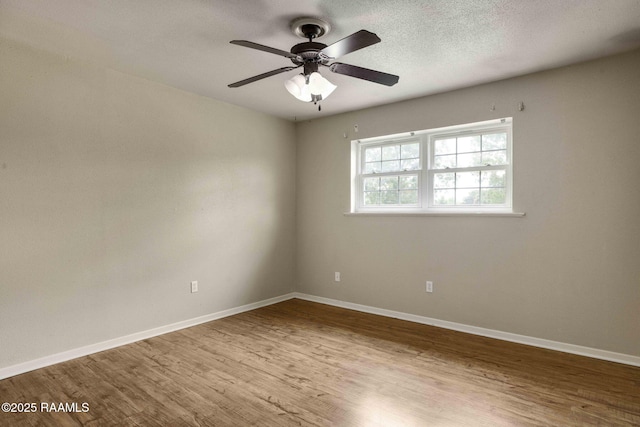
[{"x1": 0, "y1": 0, "x2": 640, "y2": 120}]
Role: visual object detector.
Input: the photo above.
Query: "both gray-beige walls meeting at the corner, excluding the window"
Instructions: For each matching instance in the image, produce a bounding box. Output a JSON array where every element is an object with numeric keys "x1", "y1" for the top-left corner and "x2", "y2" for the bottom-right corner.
[{"x1": 0, "y1": 33, "x2": 640, "y2": 367}]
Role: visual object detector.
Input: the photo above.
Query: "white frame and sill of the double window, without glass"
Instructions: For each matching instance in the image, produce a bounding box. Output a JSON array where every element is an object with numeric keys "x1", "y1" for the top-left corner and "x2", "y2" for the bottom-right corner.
[{"x1": 351, "y1": 117, "x2": 513, "y2": 214}]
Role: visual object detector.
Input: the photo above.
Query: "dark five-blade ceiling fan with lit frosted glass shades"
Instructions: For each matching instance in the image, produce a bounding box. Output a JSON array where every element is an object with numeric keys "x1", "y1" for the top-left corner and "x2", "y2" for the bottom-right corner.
[{"x1": 229, "y1": 18, "x2": 399, "y2": 108}]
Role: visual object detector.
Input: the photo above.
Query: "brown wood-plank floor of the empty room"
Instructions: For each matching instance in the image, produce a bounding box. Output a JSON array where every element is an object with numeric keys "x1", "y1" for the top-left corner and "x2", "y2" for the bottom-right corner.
[{"x1": 0, "y1": 300, "x2": 640, "y2": 426}]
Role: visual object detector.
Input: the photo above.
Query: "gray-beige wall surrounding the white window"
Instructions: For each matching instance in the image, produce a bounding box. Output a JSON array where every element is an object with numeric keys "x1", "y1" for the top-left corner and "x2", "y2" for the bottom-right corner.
[{"x1": 296, "y1": 47, "x2": 640, "y2": 356}]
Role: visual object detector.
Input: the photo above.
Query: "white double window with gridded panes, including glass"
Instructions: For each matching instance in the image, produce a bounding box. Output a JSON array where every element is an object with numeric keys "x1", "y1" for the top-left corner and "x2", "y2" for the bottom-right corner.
[{"x1": 352, "y1": 118, "x2": 513, "y2": 213}]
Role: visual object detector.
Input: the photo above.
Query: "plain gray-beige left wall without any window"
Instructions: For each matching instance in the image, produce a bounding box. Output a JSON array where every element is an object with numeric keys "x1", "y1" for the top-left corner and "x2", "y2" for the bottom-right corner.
[{"x1": 0, "y1": 39, "x2": 296, "y2": 367}]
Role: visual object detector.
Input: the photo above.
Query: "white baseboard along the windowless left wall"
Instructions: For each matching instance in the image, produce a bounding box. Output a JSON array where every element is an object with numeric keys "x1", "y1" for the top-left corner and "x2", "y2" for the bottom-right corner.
[{"x1": 0, "y1": 293, "x2": 294, "y2": 380}]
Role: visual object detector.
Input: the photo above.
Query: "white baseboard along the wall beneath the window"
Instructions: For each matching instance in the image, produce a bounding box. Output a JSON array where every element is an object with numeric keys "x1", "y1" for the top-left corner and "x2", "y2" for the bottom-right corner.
[{"x1": 293, "y1": 292, "x2": 640, "y2": 366}]
